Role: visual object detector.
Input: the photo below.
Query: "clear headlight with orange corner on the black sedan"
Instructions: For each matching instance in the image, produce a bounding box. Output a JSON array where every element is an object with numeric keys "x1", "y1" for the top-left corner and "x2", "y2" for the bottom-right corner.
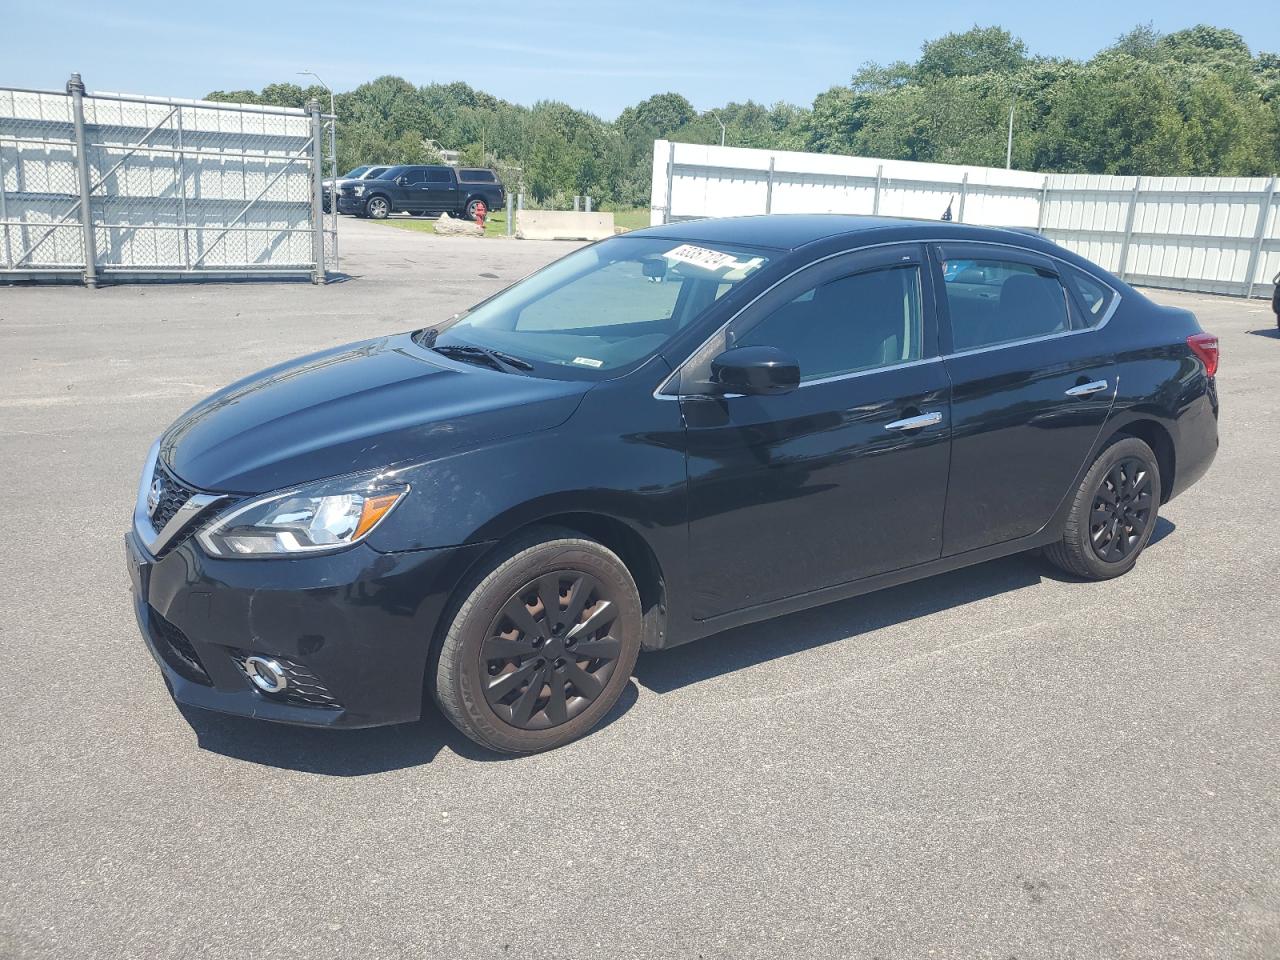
[{"x1": 198, "y1": 475, "x2": 408, "y2": 557}]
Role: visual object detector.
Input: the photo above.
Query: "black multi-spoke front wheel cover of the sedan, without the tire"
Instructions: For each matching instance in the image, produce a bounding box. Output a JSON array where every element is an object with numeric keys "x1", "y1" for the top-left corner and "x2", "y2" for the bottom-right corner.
[{"x1": 480, "y1": 571, "x2": 622, "y2": 730}]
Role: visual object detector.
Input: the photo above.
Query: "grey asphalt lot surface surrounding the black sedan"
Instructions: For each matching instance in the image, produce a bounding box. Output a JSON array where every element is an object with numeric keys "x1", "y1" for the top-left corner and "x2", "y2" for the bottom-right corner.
[{"x1": 0, "y1": 219, "x2": 1280, "y2": 960}]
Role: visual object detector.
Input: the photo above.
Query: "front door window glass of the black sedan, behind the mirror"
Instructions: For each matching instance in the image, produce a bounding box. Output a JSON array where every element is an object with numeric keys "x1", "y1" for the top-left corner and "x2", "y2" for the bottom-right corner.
[{"x1": 733, "y1": 265, "x2": 923, "y2": 381}]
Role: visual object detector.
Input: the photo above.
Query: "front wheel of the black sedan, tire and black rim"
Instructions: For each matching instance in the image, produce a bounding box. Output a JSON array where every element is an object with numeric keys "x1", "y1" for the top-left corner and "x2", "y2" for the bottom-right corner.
[{"x1": 435, "y1": 529, "x2": 641, "y2": 754}]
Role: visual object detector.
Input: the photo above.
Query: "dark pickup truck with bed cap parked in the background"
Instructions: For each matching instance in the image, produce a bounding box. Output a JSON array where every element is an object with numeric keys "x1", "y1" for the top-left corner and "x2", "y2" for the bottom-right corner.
[{"x1": 338, "y1": 164, "x2": 507, "y2": 220}]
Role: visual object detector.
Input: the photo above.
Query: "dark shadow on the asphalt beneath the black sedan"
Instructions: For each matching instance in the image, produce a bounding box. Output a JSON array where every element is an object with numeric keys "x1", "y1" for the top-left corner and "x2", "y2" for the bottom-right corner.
[{"x1": 185, "y1": 517, "x2": 1176, "y2": 777}]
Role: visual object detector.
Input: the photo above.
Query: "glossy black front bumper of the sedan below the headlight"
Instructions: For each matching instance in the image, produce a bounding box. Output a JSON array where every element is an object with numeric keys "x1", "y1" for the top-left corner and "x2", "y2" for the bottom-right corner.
[{"x1": 125, "y1": 530, "x2": 486, "y2": 727}]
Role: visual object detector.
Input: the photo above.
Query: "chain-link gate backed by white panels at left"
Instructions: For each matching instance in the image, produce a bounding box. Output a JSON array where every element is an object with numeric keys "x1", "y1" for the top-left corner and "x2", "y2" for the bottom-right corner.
[{"x1": 0, "y1": 76, "x2": 338, "y2": 284}]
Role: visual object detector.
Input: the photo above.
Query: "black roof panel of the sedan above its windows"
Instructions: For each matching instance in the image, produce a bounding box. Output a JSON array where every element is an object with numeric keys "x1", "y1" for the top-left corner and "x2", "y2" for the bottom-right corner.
[{"x1": 627, "y1": 214, "x2": 1051, "y2": 256}]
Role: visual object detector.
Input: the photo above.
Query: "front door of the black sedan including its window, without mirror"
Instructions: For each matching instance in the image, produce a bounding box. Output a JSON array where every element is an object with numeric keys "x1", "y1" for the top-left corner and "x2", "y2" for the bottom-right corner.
[{"x1": 680, "y1": 244, "x2": 950, "y2": 620}]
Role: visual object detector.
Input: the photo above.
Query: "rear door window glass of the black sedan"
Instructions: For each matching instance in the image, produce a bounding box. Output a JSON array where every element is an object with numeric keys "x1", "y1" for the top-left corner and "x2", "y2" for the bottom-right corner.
[{"x1": 942, "y1": 260, "x2": 1071, "y2": 351}]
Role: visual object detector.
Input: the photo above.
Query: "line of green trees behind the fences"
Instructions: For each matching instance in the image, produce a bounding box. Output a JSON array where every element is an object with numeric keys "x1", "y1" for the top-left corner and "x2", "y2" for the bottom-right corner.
[{"x1": 209, "y1": 23, "x2": 1280, "y2": 205}]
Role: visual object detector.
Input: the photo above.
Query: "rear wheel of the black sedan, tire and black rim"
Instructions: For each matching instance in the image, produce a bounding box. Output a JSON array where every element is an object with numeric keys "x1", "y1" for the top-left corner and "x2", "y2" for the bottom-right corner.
[{"x1": 1044, "y1": 436, "x2": 1162, "y2": 580}]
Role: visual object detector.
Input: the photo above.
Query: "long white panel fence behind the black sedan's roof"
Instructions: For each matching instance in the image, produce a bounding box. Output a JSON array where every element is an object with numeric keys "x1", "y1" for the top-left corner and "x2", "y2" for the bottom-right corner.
[{"x1": 650, "y1": 140, "x2": 1280, "y2": 297}]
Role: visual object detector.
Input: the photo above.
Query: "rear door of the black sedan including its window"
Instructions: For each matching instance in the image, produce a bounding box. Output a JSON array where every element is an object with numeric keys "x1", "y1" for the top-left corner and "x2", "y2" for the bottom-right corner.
[{"x1": 933, "y1": 243, "x2": 1116, "y2": 556}]
